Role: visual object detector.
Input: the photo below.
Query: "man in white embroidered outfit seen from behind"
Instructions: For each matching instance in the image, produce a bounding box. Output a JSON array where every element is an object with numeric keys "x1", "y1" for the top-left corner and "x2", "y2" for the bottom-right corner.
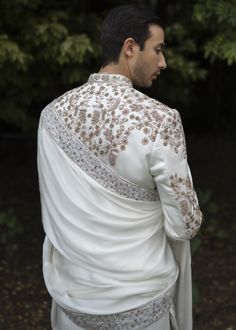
[{"x1": 38, "y1": 6, "x2": 202, "y2": 330}]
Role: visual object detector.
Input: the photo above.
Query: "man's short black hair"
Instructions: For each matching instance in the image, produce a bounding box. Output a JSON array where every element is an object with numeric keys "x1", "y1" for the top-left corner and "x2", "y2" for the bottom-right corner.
[{"x1": 101, "y1": 5, "x2": 164, "y2": 67}]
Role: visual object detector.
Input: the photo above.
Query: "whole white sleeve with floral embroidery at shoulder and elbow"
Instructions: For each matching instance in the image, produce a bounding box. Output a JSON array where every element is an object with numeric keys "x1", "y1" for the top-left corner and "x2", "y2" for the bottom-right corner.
[{"x1": 150, "y1": 110, "x2": 202, "y2": 240}]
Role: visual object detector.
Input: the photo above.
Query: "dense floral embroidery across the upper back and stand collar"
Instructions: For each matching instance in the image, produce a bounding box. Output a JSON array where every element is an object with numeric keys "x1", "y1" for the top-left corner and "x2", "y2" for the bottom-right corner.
[{"x1": 55, "y1": 74, "x2": 171, "y2": 166}]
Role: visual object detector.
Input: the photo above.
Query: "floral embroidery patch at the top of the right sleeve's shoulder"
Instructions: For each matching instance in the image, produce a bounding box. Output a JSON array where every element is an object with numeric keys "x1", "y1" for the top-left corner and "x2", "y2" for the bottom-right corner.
[{"x1": 159, "y1": 112, "x2": 187, "y2": 158}]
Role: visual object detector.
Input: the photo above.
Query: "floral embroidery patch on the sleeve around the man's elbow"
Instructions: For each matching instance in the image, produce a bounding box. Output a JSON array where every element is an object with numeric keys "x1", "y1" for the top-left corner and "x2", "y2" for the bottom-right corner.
[{"x1": 170, "y1": 174, "x2": 202, "y2": 238}]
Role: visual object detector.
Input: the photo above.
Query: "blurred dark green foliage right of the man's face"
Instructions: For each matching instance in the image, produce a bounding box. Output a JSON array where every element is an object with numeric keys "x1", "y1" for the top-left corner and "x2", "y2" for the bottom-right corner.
[{"x1": 152, "y1": 0, "x2": 236, "y2": 122}]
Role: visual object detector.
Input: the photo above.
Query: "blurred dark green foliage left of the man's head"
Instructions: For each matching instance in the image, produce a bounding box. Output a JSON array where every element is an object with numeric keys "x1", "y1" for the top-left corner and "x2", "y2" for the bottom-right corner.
[{"x1": 0, "y1": 0, "x2": 101, "y2": 132}]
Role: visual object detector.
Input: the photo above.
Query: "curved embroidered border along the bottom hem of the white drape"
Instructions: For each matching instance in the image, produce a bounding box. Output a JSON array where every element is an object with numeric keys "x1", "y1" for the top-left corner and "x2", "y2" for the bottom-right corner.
[{"x1": 61, "y1": 287, "x2": 175, "y2": 330}]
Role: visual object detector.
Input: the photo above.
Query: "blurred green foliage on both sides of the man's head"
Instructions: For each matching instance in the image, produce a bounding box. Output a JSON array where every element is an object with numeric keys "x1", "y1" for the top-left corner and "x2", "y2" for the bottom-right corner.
[{"x1": 0, "y1": 0, "x2": 236, "y2": 132}]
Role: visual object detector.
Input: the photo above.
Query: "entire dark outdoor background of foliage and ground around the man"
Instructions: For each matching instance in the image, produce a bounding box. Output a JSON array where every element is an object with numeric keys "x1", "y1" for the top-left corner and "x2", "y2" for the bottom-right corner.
[{"x1": 0, "y1": 0, "x2": 236, "y2": 330}]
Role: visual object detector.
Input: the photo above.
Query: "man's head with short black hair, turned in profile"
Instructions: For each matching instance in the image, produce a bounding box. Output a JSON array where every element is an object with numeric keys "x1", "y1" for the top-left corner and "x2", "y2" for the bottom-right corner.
[{"x1": 101, "y1": 5, "x2": 166, "y2": 87}]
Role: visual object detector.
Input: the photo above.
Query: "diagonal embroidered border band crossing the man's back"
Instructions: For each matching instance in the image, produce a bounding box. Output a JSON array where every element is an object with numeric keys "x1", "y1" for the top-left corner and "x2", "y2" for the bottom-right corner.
[{"x1": 42, "y1": 102, "x2": 159, "y2": 201}]
